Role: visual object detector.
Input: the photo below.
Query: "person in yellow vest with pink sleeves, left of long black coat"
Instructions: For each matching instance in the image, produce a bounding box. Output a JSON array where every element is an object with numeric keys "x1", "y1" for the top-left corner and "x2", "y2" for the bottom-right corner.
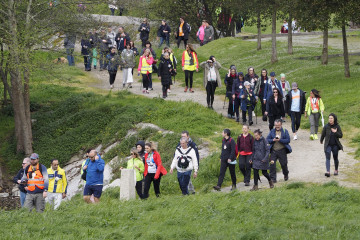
[{"x1": 138, "y1": 49, "x2": 154, "y2": 94}]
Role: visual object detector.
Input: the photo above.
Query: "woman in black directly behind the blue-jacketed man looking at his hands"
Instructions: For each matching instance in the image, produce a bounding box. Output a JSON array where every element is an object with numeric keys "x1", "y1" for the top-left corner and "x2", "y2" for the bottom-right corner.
[{"x1": 264, "y1": 88, "x2": 285, "y2": 130}]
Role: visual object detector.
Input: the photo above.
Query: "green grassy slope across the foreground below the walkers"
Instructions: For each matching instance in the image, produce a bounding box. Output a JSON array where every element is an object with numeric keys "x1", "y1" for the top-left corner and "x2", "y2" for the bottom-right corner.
[{"x1": 0, "y1": 183, "x2": 360, "y2": 239}]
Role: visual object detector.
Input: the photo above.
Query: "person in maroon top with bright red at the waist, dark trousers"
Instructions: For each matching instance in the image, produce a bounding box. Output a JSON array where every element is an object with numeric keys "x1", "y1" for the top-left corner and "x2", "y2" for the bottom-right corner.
[{"x1": 236, "y1": 124, "x2": 254, "y2": 186}]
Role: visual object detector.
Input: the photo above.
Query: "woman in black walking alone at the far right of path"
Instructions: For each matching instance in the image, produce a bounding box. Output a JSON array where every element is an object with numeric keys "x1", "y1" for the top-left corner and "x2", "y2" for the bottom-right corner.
[{"x1": 320, "y1": 113, "x2": 343, "y2": 177}]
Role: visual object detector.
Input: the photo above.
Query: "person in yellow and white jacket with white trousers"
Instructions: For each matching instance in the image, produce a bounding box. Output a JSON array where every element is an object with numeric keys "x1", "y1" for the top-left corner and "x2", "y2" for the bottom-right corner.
[{"x1": 47, "y1": 159, "x2": 67, "y2": 210}]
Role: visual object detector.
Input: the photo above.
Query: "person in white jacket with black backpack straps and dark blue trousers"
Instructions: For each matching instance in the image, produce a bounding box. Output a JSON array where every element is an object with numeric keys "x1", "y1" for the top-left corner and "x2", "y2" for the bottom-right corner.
[{"x1": 170, "y1": 138, "x2": 199, "y2": 195}]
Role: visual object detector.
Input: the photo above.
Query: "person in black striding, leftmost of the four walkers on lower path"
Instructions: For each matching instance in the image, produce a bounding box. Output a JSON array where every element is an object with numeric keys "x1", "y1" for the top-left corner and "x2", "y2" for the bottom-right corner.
[{"x1": 214, "y1": 129, "x2": 236, "y2": 191}]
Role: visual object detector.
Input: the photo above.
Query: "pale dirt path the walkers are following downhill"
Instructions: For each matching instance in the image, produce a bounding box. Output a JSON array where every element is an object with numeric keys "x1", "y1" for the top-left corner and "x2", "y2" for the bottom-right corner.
[{"x1": 86, "y1": 66, "x2": 360, "y2": 191}]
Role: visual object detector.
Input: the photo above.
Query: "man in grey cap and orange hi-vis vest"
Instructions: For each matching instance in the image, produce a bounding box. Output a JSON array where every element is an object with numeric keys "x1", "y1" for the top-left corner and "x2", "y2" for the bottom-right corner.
[{"x1": 21, "y1": 153, "x2": 49, "y2": 212}]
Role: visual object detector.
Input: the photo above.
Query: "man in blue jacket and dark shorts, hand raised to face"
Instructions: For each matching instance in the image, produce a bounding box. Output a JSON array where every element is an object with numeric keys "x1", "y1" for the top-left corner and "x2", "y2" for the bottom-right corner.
[{"x1": 83, "y1": 150, "x2": 105, "y2": 203}]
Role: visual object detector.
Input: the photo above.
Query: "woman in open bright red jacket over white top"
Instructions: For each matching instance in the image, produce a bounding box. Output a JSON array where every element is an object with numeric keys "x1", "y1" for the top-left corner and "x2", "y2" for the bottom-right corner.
[{"x1": 144, "y1": 142, "x2": 167, "y2": 199}]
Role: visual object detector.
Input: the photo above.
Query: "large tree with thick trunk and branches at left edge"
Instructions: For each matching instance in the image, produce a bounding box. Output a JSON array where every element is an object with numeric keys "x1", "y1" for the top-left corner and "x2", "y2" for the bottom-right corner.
[{"x1": 0, "y1": 0, "x2": 99, "y2": 154}]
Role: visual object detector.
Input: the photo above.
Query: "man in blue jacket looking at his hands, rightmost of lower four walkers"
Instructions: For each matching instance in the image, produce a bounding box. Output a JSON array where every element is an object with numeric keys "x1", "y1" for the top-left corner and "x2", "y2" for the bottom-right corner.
[{"x1": 266, "y1": 119, "x2": 292, "y2": 183}]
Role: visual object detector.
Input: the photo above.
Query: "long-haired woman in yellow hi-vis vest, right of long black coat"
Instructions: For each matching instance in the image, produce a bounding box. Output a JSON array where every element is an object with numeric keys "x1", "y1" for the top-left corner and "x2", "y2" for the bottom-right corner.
[{"x1": 182, "y1": 44, "x2": 199, "y2": 93}]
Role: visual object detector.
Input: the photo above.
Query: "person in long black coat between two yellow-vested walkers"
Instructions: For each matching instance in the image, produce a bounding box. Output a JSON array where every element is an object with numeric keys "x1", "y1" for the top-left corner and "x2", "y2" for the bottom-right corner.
[{"x1": 158, "y1": 52, "x2": 174, "y2": 98}]
